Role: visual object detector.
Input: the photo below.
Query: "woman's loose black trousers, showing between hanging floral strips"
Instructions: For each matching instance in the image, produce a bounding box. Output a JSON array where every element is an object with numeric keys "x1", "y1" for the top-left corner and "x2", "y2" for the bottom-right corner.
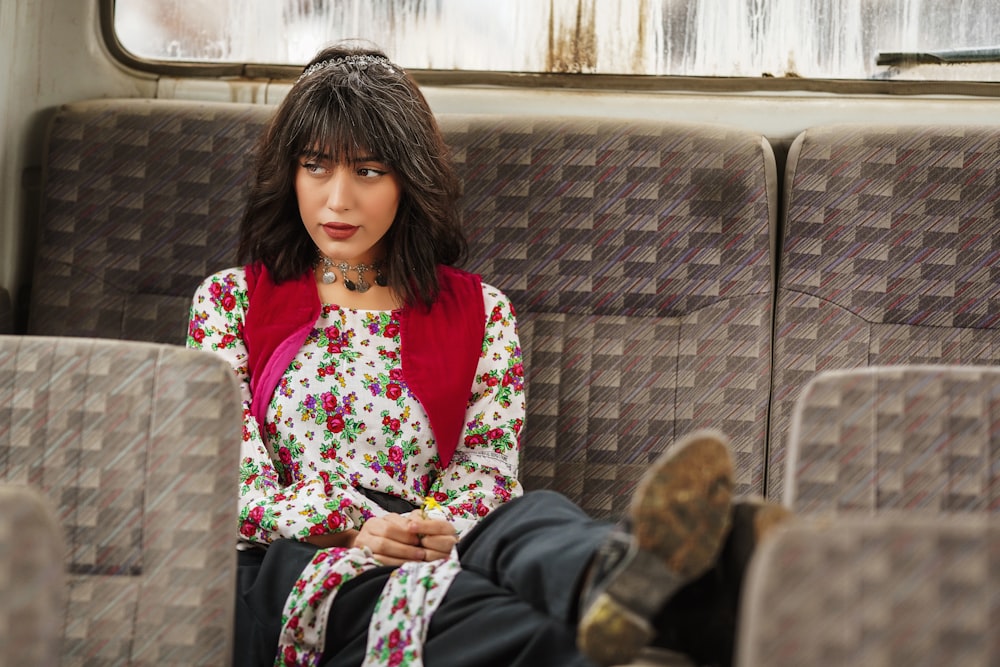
[{"x1": 234, "y1": 491, "x2": 611, "y2": 667}]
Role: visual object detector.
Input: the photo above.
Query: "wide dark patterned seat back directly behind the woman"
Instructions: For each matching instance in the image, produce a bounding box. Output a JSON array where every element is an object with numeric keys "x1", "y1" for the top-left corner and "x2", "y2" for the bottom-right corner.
[{"x1": 28, "y1": 100, "x2": 777, "y2": 517}]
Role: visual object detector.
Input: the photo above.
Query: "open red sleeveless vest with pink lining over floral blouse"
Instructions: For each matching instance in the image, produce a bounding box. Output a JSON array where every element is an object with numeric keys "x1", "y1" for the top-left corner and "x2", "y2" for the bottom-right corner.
[{"x1": 243, "y1": 264, "x2": 486, "y2": 469}]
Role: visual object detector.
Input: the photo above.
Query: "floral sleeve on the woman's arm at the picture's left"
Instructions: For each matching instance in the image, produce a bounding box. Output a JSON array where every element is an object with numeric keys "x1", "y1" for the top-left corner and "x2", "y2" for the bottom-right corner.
[{"x1": 187, "y1": 269, "x2": 384, "y2": 544}]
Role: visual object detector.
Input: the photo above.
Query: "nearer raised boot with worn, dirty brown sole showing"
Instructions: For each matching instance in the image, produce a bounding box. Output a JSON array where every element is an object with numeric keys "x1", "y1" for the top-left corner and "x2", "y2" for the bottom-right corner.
[{"x1": 577, "y1": 430, "x2": 733, "y2": 665}]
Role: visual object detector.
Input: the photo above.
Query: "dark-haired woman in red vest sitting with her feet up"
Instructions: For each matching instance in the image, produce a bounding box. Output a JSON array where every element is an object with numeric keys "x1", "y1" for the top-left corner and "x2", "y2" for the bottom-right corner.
[{"x1": 188, "y1": 45, "x2": 780, "y2": 667}]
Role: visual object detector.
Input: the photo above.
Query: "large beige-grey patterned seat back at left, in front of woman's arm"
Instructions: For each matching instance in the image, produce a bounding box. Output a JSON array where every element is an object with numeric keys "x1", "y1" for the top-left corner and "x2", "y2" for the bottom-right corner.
[{"x1": 0, "y1": 336, "x2": 242, "y2": 666}]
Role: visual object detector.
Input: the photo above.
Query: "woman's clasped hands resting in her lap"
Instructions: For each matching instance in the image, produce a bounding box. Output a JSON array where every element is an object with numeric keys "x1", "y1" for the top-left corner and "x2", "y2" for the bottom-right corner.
[{"x1": 306, "y1": 510, "x2": 458, "y2": 565}]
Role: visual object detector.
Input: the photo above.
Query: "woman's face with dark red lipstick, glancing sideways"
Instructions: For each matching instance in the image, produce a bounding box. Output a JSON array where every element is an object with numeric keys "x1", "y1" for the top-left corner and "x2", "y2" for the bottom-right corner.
[{"x1": 295, "y1": 154, "x2": 402, "y2": 264}]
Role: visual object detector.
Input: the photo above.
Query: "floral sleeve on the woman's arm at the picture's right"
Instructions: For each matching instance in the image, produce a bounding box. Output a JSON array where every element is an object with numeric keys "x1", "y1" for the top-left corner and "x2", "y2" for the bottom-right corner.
[{"x1": 430, "y1": 285, "x2": 525, "y2": 534}]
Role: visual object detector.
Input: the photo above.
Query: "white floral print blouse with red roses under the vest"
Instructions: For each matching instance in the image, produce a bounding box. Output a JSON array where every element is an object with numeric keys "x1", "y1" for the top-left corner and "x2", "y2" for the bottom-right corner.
[{"x1": 188, "y1": 268, "x2": 525, "y2": 544}]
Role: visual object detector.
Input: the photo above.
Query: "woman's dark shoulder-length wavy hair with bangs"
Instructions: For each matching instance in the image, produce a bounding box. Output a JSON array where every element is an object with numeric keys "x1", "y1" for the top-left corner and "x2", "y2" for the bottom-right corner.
[{"x1": 237, "y1": 43, "x2": 468, "y2": 306}]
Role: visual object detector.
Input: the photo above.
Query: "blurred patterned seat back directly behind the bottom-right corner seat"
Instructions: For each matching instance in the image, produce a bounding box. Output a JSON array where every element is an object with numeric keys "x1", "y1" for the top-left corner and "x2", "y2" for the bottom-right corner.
[{"x1": 784, "y1": 365, "x2": 1000, "y2": 514}]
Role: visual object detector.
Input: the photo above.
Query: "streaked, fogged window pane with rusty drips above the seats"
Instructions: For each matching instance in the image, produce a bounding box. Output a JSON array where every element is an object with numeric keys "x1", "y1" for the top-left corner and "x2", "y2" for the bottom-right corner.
[{"x1": 115, "y1": 0, "x2": 1000, "y2": 80}]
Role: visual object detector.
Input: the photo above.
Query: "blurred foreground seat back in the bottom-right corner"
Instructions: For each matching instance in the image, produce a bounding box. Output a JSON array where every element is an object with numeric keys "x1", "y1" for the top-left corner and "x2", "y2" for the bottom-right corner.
[{"x1": 736, "y1": 514, "x2": 1000, "y2": 667}]
